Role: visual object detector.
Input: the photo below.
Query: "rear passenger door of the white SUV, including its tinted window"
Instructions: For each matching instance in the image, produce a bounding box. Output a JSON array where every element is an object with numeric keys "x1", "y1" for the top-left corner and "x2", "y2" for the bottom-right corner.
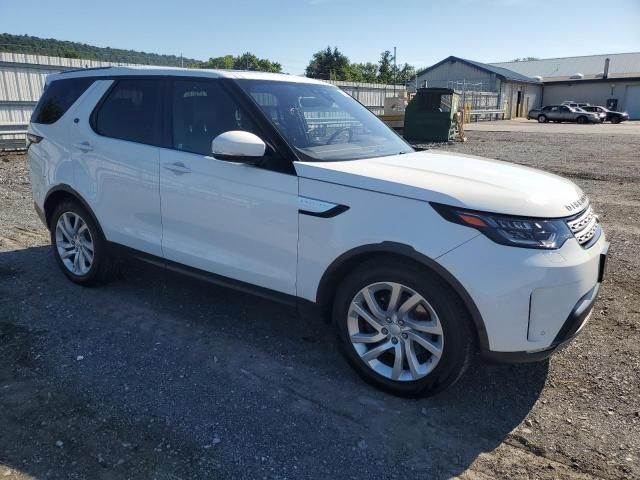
[{"x1": 69, "y1": 77, "x2": 165, "y2": 256}]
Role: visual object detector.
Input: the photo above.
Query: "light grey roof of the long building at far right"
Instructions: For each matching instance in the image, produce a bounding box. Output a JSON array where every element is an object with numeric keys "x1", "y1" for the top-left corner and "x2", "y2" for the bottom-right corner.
[{"x1": 490, "y1": 52, "x2": 640, "y2": 82}]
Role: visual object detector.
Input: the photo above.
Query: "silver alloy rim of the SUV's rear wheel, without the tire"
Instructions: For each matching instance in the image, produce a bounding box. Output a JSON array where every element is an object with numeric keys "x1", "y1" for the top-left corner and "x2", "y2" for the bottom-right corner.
[{"x1": 55, "y1": 212, "x2": 94, "y2": 275}]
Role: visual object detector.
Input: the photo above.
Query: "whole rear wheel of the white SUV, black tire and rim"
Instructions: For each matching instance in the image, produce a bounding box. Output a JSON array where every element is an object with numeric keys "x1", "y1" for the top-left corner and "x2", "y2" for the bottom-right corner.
[{"x1": 49, "y1": 200, "x2": 116, "y2": 287}]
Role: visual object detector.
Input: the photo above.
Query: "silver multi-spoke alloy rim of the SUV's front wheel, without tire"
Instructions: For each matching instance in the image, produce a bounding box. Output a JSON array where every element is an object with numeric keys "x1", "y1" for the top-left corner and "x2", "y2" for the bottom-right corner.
[{"x1": 347, "y1": 282, "x2": 444, "y2": 381}]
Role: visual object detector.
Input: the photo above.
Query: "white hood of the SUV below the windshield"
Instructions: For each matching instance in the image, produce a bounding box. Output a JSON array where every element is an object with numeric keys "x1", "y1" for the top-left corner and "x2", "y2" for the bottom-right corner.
[{"x1": 295, "y1": 151, "x2": 587, "y2": 218}]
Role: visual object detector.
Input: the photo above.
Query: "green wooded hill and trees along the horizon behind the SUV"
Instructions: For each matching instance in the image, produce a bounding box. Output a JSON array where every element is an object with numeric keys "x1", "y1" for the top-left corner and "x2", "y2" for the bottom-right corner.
[{"x1": 0, "y1": 33, "x2": 415, "y2": 84}]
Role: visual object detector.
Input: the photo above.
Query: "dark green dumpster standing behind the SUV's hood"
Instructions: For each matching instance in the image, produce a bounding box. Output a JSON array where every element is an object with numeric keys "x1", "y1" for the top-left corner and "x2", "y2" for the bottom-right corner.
[{"x1": 403, "y1": 88, "x2": 460, "y2": 142}]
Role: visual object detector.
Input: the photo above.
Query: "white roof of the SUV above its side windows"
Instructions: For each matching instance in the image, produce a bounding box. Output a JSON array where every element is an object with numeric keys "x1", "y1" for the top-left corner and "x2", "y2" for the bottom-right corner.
[{"x1": 47, "y1": 66, "x2": 326, "y2": 85}]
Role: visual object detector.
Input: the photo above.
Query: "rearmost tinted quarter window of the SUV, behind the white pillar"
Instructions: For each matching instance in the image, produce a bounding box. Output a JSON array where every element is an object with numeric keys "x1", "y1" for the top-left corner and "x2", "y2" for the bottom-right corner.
[{"x1": 31, "y1": 77, "x2": 94, "y2": 124}]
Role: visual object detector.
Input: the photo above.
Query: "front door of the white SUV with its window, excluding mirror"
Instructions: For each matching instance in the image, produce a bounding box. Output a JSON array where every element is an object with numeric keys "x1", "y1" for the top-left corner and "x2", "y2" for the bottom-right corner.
[{"x1": 160, "y1": 78, "x2": 298, "y2": 295}]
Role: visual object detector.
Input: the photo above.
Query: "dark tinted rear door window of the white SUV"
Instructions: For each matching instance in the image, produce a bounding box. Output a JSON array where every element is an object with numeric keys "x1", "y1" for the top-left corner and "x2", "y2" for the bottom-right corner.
[{"x1": 92, "y1": 78, "x2": 162, "y2": 145}]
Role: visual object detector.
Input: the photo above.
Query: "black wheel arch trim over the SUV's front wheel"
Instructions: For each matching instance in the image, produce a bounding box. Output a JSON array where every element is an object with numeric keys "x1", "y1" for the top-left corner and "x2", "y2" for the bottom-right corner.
[{"x1": 316, "y1": 242, "x2": 489, "y2": 352}]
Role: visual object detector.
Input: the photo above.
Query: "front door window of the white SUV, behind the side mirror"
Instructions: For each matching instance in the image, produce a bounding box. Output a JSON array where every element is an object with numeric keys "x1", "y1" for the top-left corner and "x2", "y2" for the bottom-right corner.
[{"x1": 172, "y1": 80, "x2": 258, "y2": 155}]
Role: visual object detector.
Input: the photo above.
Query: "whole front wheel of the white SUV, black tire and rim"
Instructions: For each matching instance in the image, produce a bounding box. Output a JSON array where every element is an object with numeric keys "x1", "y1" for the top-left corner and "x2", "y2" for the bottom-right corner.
[{"x1": 333, "y1": 260, "x2": 475, "y2": 397}]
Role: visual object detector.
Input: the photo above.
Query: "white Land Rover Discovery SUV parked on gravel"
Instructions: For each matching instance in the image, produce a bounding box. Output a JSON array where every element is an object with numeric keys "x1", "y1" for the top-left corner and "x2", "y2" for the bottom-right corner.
[{"x1": 28, "y1": 67, "x2": 608, "y2": 396}]
